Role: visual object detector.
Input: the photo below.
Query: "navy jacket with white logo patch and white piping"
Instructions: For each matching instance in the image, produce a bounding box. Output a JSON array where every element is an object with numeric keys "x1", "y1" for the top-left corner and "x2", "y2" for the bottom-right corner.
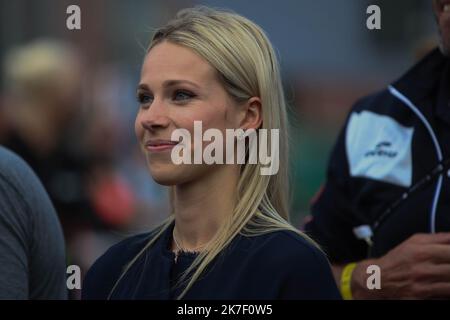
[{"x1": 305, "y1": 49, "x2": 450, "y2": 263}]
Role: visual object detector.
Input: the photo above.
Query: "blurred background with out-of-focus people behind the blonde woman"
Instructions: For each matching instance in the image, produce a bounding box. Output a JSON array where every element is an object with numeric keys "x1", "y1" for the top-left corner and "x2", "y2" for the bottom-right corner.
[{"x1": 0, "y1": 0, "x2": 437, "y2": 298}]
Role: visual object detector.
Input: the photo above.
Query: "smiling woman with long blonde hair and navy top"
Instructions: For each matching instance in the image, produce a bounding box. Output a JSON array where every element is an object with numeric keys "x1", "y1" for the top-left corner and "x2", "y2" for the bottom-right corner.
[{"x1": 83, "y1": 7, "x2": 339, "y2": 299}]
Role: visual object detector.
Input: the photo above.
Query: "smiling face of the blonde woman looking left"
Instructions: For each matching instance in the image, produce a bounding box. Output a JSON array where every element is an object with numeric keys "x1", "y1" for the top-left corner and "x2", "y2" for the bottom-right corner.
[{"x1": 135, "y1": 41, "x2": 242, "y2": 185}]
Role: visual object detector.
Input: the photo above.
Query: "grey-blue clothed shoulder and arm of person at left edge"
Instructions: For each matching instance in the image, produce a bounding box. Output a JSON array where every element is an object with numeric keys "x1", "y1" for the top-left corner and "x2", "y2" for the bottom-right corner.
[{"x1": 0, "y1": 147, "x2": 67, "y2": 299}]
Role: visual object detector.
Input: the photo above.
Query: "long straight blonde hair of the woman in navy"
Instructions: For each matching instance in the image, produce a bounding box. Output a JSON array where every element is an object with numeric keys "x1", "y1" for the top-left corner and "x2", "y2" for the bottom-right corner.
[{"x1": 109, "y1": 6, "x2": 316, "y2": 298}]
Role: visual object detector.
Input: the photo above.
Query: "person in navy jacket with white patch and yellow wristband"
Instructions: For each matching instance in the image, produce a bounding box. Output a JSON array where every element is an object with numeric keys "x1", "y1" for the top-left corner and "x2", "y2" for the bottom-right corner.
[{"x1": 305, "y1": 0, "x2": 450, "y2": 299}]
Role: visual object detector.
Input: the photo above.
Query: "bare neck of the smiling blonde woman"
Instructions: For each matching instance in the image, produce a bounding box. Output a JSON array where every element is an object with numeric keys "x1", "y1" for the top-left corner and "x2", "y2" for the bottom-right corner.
[{"x1": 174, "y1": 165, "x2": 239, "y2": 251}]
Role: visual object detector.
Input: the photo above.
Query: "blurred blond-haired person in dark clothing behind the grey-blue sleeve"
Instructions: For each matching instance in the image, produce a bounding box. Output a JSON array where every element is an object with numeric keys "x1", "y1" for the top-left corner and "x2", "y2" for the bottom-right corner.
[{"x1": 0, "y1": 39, "x2": 100, "y2": 238}]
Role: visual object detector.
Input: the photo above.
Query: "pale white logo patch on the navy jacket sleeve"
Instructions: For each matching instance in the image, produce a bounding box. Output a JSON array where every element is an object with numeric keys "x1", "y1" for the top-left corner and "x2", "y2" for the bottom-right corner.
[{"x1": 345, "y1": 111, "x2": 414, "y2": 187}]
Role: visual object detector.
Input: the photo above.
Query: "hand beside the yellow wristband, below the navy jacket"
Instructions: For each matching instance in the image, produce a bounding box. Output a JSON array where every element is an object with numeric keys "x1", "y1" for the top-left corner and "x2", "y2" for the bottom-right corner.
[{"x1": 351, "y1": 233, "x2": 450, "y2": 299}]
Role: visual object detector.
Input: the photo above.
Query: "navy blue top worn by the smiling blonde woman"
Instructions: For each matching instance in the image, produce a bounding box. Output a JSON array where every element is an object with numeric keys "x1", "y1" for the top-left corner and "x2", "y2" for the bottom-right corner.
[{"x1": 82, "y1": 223, "x2": 340, "y2": 300}]
